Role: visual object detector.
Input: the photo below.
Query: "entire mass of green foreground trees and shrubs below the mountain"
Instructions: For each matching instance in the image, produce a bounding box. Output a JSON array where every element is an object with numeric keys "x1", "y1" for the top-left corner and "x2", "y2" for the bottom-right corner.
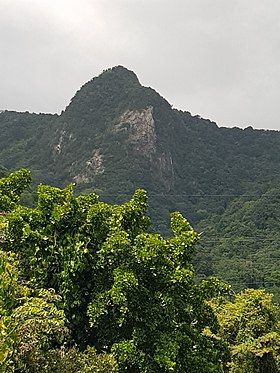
[{"x1": 0, "y1": 170, "x2": 280, "y2": 373}]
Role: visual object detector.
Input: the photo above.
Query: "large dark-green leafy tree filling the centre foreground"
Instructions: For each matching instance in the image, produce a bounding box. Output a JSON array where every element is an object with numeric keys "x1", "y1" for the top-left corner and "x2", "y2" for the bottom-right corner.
[{"x1": 1, "y1": 170, "x2": 228, "y2": 373}]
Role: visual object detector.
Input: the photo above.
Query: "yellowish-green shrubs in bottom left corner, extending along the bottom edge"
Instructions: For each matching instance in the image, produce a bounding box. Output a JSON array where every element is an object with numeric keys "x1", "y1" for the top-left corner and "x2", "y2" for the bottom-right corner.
[{"x1": 0, "y1": 247, "x2": 117, "y2": 373}]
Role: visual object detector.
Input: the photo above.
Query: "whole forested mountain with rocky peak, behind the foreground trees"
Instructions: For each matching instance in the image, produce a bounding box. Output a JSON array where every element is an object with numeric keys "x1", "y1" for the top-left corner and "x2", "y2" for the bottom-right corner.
[{"x1": 0, "y1": 66, "x2": 280, "y2": 300}]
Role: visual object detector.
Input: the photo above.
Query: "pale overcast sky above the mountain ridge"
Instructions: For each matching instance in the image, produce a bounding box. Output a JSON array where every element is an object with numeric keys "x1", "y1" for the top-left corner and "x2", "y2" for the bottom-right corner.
[{"x1": 0, "y1": 0, "x2": 280, "y2": 130}]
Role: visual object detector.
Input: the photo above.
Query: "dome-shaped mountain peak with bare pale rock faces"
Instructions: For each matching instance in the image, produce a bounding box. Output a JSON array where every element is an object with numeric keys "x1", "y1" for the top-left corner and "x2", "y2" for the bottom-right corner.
[{"x1": 44, "y1": 66, "x2": 178, "y2": 193}]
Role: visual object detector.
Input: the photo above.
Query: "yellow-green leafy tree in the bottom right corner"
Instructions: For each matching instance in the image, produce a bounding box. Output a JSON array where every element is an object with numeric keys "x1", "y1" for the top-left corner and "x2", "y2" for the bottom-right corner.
[{"x1": 213, "y1": 289, "x2": 280, "y2": 373}]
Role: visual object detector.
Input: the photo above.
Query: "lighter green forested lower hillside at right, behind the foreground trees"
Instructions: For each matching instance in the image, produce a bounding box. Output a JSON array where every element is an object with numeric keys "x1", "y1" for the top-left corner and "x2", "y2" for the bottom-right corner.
[{"x1": 195, "y1": 183, "x2": 280, "y2": 303}]
